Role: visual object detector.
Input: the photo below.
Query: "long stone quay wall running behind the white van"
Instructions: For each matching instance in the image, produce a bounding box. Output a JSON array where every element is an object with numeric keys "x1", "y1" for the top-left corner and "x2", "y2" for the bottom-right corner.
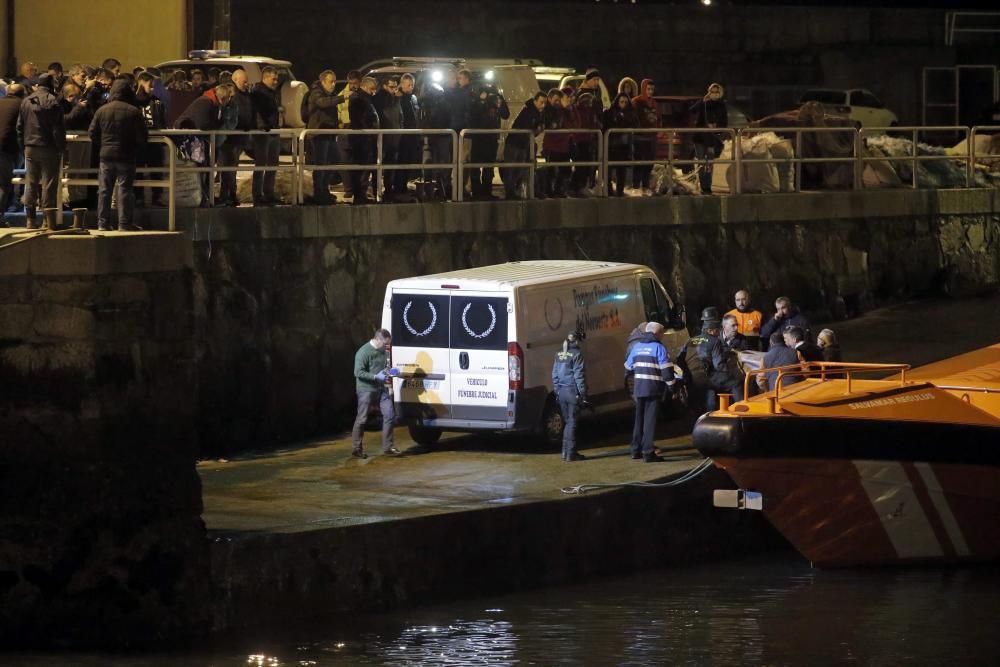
[{"x1": 180, "y1": 191, "x2": 1000, "y2": 453}]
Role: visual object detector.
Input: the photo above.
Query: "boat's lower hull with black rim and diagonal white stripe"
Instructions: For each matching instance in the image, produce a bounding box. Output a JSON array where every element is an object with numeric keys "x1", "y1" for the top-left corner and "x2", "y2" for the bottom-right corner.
[{"x1": 694, "y1": 415, "x2": 1000, "y2": 567}]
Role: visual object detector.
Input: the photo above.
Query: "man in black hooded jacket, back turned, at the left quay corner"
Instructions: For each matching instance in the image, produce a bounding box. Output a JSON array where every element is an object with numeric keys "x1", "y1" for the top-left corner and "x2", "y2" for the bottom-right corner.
[{"x1": 90, "y1": 79, "x2": 148, "y2": 231}]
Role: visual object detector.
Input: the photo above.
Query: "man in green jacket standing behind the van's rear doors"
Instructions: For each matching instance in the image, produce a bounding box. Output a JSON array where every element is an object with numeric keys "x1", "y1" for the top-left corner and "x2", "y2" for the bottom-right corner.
[{"x1": 351, "y1": 329, "x2": 399, "y2": 459}]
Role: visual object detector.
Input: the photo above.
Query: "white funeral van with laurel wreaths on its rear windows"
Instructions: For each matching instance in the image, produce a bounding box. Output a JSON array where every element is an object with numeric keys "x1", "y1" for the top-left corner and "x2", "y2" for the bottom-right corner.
[{"x1": 382, "y1": 260, "x2": 688, "y2": 445}]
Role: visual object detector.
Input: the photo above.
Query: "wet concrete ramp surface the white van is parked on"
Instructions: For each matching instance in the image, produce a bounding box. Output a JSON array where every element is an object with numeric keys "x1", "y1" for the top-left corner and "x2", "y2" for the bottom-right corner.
[{"x1": 198, "y1": 296, "x2": 1000, "y2": 535}]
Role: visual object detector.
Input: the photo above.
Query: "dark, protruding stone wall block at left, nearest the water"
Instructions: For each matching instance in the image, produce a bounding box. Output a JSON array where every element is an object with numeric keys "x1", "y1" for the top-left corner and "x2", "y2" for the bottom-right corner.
[{"x1": 0, "y1": 234, "x2": 208, "y2": 646}]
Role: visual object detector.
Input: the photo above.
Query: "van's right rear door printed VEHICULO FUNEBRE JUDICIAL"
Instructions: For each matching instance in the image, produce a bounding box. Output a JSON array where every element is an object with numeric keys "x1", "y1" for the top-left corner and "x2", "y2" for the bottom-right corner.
[{"x1": 450, "y1": 290, "x2": 513, "y2": 422}]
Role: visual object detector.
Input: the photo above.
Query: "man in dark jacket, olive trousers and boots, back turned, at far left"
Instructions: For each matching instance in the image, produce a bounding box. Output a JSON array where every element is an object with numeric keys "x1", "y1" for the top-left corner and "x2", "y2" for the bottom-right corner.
[{"x1": 17, "y1": 74, "x2": 66, "y2": 229}]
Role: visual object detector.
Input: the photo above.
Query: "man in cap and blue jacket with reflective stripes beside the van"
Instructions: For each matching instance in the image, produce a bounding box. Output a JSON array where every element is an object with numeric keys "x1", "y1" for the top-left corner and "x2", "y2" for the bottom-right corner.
[{"x1": 625, "y1": 322, "x2": 676, "y2": 463}]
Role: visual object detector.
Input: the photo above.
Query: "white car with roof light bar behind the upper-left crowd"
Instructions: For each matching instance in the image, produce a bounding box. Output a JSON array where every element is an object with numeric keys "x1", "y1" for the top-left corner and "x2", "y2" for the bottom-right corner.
[{"x1": 156, "y1": 50, "x2": 309, "y2": 127}]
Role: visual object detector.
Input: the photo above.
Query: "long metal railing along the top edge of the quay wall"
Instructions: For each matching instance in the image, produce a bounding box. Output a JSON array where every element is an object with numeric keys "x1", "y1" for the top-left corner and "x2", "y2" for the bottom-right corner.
[{"x1": 7, "y1": 126, "x2": 1000, "y2": 230}]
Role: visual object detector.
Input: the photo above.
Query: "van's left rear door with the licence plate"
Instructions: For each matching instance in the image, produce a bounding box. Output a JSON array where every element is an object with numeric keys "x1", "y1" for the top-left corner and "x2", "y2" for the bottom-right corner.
[{"x1": 391, "y1": 287, "x2": 451, "y2": 420}]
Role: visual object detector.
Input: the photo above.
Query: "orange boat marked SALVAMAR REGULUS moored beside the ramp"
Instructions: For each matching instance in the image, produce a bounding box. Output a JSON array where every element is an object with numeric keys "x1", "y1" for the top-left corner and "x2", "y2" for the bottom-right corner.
[{"x1": 693, "y1": 344, "x2": 1000, "y2": 567}]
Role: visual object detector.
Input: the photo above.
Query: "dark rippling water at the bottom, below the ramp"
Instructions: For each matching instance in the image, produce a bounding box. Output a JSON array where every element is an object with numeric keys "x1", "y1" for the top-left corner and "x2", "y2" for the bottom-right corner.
[{"x1": 9, "y1": 554, "x2": 1000, "y2": 667}]
